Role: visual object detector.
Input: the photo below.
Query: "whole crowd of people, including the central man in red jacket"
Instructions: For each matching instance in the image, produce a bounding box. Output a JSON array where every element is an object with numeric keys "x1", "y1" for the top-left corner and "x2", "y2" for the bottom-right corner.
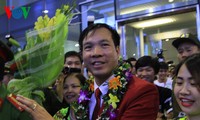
[{"x1": 0, "y1": 23, "x2": 200, "y2": 120}]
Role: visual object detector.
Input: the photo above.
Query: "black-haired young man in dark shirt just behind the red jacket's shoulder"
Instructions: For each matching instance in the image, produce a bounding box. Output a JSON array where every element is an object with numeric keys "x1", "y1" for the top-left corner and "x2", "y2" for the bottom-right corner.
[{"x1": 135, "y1": 56, "x2": 173, "y2": 120}]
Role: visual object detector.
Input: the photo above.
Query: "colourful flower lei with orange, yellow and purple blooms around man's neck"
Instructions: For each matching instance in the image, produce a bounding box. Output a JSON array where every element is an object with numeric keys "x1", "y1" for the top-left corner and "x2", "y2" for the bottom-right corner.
[{"x1": 72, "y1": 60, "x2": 132, "y2": 120}]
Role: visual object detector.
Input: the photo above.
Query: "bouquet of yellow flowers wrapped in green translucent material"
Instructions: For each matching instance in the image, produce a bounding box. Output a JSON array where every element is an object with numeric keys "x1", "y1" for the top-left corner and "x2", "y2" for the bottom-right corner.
[{"x1": 8, "y1": 5, "x2": 74, "y2": 103}]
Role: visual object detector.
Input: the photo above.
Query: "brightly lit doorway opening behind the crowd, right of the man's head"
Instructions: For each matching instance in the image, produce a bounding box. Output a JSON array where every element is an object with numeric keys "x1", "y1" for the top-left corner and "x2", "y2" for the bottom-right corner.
[{"x1": 118, "y1": 7, "x2": 197, "y2": 63}]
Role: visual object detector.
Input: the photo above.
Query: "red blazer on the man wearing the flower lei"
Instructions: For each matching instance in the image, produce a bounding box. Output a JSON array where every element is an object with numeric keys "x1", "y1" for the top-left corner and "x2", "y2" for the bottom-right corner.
[{"x1": 117, "y1": 76, "x2": 159, "y2": 120}]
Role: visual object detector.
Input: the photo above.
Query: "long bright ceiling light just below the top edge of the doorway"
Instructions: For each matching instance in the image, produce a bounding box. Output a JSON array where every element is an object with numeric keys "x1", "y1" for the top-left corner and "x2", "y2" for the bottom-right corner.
[{"x1": 132, "y1": 18, "x2": 175, "y2": 28}]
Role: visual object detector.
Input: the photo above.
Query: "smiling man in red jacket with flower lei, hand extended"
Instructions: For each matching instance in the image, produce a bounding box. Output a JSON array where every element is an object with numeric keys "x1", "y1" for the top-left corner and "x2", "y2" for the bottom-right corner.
[{"x1": 17, "y1": 23, "x2": 159, "y2": 120}]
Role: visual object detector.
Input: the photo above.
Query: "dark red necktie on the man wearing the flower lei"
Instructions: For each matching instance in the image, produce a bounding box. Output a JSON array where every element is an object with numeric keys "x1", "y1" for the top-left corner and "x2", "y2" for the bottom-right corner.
[{"x1": 92, "y1": 88, "x2": 101, "y2": 120}]
